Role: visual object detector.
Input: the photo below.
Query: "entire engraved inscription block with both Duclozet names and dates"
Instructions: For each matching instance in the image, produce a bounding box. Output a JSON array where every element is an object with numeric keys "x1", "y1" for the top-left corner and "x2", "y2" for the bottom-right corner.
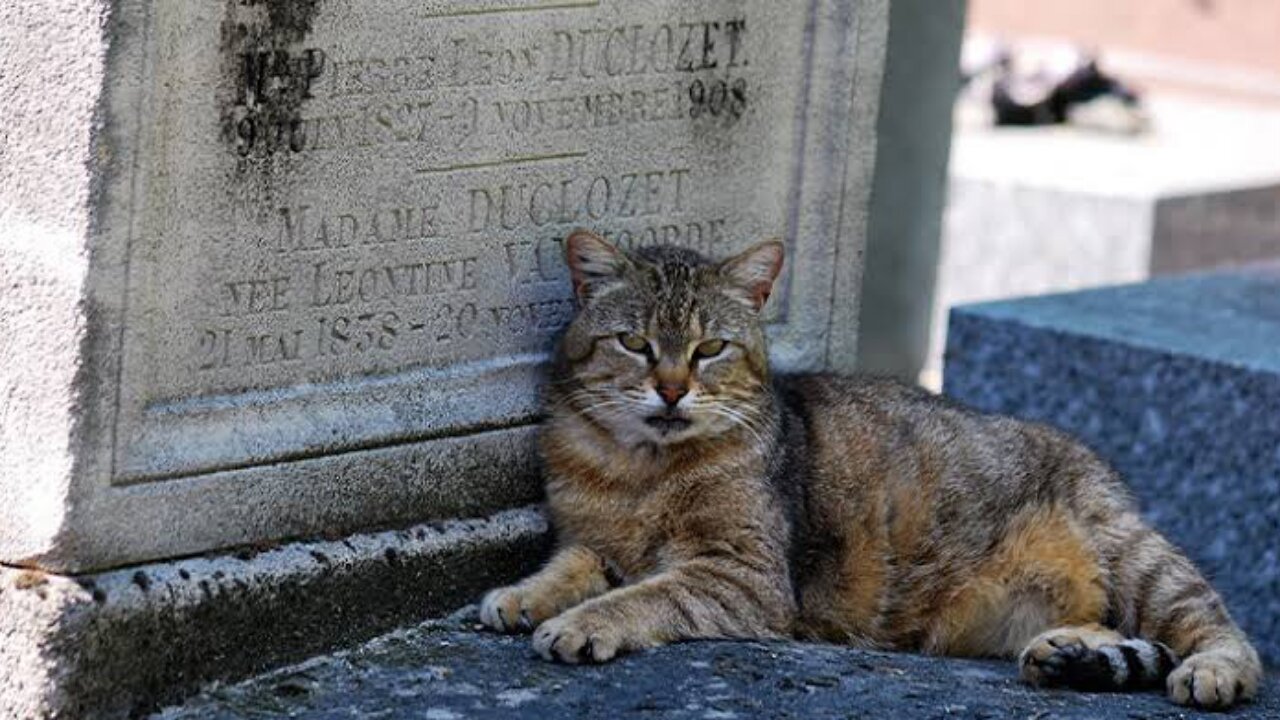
[{"x1": 186, "y1": 0, "x2": 768, "y2": 389}]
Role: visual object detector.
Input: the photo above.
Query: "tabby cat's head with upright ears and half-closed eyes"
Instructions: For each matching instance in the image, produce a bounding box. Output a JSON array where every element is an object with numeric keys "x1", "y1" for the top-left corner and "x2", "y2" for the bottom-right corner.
[{"x1": 557, "y1": 231, "x2": 783, "y2": 446}]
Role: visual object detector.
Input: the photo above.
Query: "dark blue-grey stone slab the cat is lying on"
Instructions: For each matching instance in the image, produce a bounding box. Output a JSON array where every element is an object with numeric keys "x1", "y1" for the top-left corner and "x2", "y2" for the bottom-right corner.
[{"x1": 152, "y1": 612, "x2": 1280, "y2": 720}]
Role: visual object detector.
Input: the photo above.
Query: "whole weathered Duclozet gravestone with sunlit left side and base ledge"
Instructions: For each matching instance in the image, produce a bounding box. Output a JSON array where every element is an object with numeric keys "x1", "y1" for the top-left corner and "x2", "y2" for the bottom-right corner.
[{"x1": 0, "y1": 0, "x2": 887, "y2": 716}]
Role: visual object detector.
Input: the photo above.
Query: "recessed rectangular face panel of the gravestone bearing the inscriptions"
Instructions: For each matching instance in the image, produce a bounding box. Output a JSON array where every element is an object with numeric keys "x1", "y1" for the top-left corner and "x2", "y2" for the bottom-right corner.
[{"x1": 115, "y1": 0, "x2": 808, "y2": 482}]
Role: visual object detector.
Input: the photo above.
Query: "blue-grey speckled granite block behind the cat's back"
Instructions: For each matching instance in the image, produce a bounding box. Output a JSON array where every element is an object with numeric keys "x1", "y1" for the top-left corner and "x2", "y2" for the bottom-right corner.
[{"x1": 945, "y1": 264, "x2": 1280, "y2": 664}]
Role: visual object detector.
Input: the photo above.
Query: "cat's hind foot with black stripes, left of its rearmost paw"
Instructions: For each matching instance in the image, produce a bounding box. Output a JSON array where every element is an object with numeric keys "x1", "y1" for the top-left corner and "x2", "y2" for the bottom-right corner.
[{"x1": 1018, "y1": 625, "x2": 1178, "y2": 692}]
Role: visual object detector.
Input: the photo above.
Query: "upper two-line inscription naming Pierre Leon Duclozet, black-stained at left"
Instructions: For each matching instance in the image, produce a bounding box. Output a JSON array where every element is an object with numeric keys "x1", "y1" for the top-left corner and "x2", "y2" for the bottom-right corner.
[{"x1": 225, "y1": 18, "x2": 749, "y2": 155}]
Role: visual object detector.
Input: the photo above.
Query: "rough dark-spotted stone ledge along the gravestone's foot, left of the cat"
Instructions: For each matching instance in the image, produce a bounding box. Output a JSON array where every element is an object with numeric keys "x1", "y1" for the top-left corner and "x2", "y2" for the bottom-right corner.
[{"x1": 0, "y1": 507, "x2": 550, "y2": 720}]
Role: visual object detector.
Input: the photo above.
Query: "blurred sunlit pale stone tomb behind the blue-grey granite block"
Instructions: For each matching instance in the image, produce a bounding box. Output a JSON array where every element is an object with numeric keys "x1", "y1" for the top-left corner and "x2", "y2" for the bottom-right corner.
[{"x1": 927, "y1": 97, "x2": 1280, "y2": 382}]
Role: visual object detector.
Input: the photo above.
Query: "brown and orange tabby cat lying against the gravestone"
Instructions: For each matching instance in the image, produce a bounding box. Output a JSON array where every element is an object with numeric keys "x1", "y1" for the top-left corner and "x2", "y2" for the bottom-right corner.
[{"x1": 481, "y1": 231, "x2": 1262, "y2": 708}]
